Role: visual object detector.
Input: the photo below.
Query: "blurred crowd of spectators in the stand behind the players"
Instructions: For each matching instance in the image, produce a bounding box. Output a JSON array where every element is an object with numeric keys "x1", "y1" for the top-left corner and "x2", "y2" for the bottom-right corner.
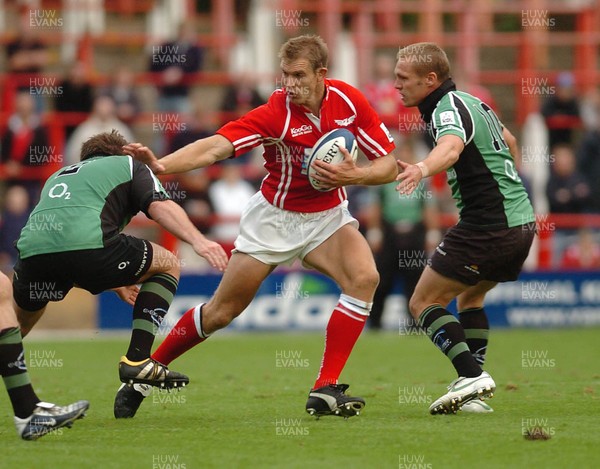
[{"x1": 0, "y1": 16, "x2": 600, "y2": 276}]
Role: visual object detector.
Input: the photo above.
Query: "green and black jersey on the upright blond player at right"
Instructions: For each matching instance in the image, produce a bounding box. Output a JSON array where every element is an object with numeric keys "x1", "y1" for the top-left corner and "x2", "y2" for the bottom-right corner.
[{"x1": 419, "y1": 79, "x2": 535, "y2": 230}]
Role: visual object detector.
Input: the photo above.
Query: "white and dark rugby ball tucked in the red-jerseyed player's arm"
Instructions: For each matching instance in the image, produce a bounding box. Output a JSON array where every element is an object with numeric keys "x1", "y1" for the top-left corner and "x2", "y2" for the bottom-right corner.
[{"x1": 306, "y1": 129, "x2": 358, "y2": 192}]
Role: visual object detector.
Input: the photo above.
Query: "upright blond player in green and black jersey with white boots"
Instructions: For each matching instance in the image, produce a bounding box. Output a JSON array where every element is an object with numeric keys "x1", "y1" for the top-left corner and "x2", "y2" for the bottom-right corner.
[{"x1": 394, "y1": 43, "x2": 535, "y2": 414}]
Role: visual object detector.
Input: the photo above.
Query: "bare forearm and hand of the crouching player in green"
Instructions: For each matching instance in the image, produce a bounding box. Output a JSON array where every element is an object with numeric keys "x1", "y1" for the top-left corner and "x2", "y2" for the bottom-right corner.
[{"x1": 148, "y1": 200, "x2": 228, "y2": 272}]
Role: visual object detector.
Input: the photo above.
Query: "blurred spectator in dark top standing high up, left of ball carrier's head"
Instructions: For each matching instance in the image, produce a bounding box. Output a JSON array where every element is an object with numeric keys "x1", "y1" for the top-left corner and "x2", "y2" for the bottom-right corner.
[{"x1": 150, "y1": 21, "x2": 204, "y2": 113}]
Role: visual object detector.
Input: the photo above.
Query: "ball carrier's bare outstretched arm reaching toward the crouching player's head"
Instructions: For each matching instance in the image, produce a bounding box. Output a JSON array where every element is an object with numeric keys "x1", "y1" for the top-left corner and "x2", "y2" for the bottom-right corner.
[{"x1": 123, "y1": 134, "x2": 234, "y2": 174}]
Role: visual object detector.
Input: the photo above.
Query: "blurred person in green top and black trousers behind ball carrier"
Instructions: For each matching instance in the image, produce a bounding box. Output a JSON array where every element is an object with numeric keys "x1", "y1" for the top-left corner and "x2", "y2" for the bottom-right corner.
[{"x1": 366, "y1": 142, "x2": 440, "y2": 329}]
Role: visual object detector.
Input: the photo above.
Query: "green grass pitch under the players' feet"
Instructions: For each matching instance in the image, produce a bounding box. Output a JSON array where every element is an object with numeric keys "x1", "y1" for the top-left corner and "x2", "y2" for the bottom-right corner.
[{"x1": 0, "y1": 329, "x2": 600, "y2": 469}]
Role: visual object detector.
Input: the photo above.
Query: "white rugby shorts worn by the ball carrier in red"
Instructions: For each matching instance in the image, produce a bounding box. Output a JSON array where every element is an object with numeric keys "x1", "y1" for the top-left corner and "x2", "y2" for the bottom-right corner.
[{"x1": 233, "y1": 191, "x2": 358, "y2": 265}]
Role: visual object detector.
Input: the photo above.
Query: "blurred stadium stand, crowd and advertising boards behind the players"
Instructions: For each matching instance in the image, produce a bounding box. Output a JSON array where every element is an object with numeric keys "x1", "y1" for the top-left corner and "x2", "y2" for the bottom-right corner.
[{"x1": 0, "y1": 0, "x2": 600, "y2": 333}]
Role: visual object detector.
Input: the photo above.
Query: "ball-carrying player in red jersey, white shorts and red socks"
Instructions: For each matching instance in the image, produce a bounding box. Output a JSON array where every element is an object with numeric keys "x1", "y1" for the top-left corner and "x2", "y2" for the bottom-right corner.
[{"x1": 115, "y1": 36, "x2": 398, "y2": 418}]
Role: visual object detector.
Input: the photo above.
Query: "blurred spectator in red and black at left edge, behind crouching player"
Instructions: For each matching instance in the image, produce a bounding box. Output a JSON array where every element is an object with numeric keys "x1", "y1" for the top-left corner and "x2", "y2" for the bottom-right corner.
[{"x1": 0, "y1": 91, "x2": 51, "y2": 205}]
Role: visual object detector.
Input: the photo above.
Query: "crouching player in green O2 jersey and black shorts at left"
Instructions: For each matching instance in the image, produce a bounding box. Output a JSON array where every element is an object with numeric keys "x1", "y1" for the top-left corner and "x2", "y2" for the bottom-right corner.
[{"x1": 13, "y1": 130, "x2": 227, "y2": 414}]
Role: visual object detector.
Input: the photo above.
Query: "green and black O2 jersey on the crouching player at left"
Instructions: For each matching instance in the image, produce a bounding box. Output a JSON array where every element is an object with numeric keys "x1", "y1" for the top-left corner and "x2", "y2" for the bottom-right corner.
[{"x1": 17, "y1": 156, "x2": 169, "y2": 258}]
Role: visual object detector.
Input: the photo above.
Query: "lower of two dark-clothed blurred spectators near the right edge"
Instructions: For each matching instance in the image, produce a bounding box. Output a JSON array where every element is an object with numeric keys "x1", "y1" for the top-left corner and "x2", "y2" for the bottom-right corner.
[{"x1": 546, "y1": 144, "x2": 591, "y2": 213}]
